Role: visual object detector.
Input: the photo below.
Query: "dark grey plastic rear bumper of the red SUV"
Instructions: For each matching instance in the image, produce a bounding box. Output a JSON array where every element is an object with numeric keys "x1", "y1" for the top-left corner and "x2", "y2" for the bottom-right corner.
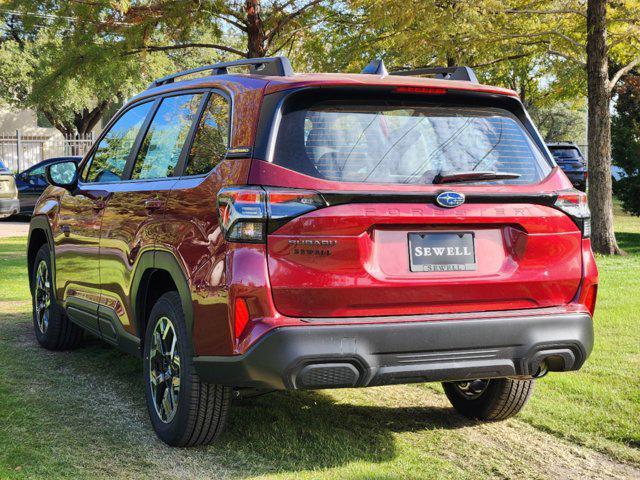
[{"x1": 194, "y1": 313, "x2": 593, "y2": 389}]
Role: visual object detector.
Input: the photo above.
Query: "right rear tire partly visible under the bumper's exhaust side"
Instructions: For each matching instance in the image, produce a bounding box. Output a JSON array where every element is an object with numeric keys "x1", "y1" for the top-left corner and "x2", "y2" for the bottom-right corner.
[{"x1": 442, "y1": 378, "x2": 534, "y2": 421}]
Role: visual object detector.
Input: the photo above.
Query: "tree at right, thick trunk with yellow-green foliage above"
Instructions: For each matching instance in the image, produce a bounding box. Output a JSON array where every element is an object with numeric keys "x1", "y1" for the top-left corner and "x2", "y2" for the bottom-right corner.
[{"x1": 503, "y1": 0, "x2": 640, "y2": 254}]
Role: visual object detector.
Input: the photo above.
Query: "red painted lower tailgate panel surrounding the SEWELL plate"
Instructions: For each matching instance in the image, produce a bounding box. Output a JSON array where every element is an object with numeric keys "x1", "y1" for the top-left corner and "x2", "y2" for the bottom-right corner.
[{"x1": 268, "y1": 204, "x2": 582, "y2": 317}]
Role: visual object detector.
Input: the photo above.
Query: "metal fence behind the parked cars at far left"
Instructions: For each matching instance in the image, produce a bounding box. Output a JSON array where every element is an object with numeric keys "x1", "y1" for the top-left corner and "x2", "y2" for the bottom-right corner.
[{"x1": 0, "y1": 130, "x2": 94, "y2": 172}]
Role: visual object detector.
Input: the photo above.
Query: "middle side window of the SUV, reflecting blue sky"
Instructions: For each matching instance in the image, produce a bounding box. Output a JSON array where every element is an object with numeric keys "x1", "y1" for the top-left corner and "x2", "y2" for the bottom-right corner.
[{"x1": 131, "y1": 94, "x2": 202, "y2": 179}]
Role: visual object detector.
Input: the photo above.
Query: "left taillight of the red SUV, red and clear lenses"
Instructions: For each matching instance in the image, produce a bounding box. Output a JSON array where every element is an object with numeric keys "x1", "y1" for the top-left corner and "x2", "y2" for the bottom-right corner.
[{"x1": 218, "y1": 186, "x2": 326, "y2": 243}]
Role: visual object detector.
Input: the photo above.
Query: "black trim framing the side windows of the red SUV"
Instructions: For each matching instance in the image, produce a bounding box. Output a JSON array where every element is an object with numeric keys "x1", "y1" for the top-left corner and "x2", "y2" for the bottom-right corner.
[{"x1": 78, "y1": 88, "x2": 234, "y2": 186}]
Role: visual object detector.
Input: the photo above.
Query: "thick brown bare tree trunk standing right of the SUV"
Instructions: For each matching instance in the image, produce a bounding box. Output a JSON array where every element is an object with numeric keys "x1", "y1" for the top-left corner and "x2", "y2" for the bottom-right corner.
[{"x1": 587, "y1": 0, "x2": 621, "y2": 255}]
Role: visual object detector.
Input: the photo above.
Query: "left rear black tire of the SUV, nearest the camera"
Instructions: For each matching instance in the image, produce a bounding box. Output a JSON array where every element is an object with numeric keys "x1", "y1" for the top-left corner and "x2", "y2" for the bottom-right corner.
[{"x1": 143, "y1": 292, "x2": 231, "y2": 447}]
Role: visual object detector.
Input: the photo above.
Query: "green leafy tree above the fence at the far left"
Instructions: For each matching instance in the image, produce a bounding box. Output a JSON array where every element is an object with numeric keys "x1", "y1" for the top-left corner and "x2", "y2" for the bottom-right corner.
[{"x1": 0, "y1": 10, "x2": 171, "y2": 136}]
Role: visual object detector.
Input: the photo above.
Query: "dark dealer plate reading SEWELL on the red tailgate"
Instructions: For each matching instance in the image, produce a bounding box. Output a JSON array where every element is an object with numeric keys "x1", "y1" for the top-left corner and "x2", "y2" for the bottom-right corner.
[{"x1": 409, "y1": 232, "x2": 476, "y2": 272}]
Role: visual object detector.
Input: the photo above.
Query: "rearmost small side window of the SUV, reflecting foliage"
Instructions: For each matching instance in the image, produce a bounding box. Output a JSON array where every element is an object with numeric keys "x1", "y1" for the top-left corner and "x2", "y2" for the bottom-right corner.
[{"x1": 184, "y1": 93, "x2": 229, "y2": 175}]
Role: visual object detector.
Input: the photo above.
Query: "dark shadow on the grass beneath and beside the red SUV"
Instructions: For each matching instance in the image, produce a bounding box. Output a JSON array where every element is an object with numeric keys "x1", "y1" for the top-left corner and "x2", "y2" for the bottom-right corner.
[{"x1": 0, "y1": 313, "x2": 469, "y2": 477}]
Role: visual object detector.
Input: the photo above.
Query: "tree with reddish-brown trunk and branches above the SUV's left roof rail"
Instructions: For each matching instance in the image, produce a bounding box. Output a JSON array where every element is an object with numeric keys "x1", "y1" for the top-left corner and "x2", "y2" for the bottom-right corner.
[{"x1": 110, "y1": 0, "x2": 332, "y2": 58}]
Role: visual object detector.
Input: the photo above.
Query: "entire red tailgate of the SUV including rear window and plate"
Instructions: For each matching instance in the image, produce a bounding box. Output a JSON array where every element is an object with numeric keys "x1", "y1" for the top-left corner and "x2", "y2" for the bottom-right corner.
[{"x1": 263, "y1": 94, "x2": 582, "y2": 317}]
